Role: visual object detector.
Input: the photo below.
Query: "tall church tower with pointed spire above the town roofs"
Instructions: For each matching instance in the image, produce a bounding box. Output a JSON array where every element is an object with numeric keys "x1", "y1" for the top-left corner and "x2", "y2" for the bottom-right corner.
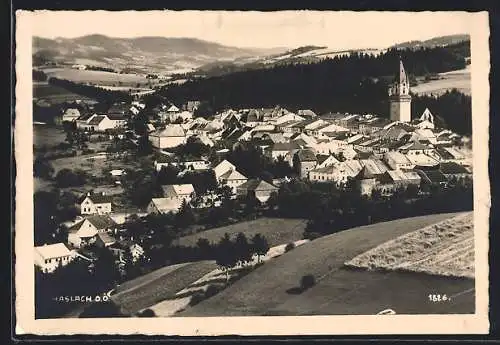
[{"x1": 389, "y1": 60, "x2": 411, "y2": 122}]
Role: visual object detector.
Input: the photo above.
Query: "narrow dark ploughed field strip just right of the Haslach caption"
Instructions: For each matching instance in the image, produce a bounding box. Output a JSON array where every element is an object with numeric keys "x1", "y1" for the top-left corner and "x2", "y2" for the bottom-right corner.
[{"x1": 111, "y1": 261, "x2": 217, "y2": 314}]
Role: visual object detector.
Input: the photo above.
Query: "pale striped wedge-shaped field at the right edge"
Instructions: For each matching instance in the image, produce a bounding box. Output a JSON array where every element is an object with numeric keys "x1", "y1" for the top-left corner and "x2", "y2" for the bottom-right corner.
[{"x1": 346, "y1": 212, "x2": 474, "y2": 279}]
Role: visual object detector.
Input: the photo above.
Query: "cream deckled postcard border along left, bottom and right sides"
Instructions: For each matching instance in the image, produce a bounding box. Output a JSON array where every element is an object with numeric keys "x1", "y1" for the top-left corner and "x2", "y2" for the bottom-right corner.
[{"x1": 14, "y1": 11, "x2": 491, "y2": 336}]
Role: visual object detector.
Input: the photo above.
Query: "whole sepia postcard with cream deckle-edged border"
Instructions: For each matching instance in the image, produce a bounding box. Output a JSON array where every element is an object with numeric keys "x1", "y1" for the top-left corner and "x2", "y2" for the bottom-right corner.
[{"x1": 15, "y1": 11, "x2": 490, "y2": 336}]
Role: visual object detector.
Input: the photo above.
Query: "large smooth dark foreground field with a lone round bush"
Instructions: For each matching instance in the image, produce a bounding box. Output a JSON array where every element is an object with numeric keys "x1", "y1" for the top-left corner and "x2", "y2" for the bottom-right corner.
[{"x1": 176, "y1": 213, "x2": 474, "y2": 316}]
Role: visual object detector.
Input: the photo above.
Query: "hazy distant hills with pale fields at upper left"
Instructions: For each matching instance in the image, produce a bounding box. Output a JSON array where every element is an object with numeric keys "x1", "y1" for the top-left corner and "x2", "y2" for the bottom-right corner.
[{"x1": 33, "y1": 35, "x2": 281, "y2": 73}]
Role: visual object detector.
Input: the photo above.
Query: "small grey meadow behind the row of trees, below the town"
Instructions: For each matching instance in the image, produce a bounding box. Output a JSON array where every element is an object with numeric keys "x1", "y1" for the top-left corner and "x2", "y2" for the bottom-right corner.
[{"x1": 179, "y1": 218, "x2": 307, "y2": 247}]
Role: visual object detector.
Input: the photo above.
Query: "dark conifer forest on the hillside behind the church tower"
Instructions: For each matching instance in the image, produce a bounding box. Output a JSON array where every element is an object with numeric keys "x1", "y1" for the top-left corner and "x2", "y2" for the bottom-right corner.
[{"x1": 159, "y1": 42, "x2": 471, "y2": 133}]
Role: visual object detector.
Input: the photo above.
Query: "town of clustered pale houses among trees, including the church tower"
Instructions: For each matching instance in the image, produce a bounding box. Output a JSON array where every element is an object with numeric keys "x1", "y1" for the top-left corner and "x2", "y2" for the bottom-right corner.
[{"x1": 34, "y1": 60, "x2": 473, "y2": 317}]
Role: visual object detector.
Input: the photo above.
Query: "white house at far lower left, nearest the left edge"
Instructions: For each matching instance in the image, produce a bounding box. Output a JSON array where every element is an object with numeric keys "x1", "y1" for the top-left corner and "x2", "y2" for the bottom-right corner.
[{"x1": 35, "y1": 243, "x2": 75, "y2": 273}]
